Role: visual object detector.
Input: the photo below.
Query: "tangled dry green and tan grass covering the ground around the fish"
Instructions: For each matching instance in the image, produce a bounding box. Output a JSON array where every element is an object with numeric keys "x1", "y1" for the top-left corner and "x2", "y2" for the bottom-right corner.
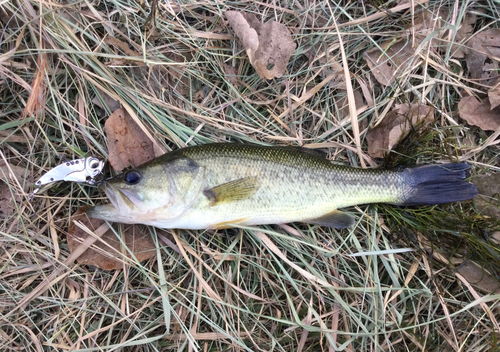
[{"x1": 0, "y1": 0, "x2": 500, "y2": 351}]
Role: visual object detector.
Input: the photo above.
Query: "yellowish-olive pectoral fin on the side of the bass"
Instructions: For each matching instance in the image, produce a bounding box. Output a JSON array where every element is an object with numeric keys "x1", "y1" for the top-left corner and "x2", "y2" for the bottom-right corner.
[{"x1": 203, "y1": 177, "x2": 259, "y2": 206}]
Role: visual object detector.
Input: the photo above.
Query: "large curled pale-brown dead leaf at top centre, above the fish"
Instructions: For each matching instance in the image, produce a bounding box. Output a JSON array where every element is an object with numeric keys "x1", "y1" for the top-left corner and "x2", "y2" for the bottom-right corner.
[{"x1": 225, "y1": 11, "x2": 296, "y2": 79}]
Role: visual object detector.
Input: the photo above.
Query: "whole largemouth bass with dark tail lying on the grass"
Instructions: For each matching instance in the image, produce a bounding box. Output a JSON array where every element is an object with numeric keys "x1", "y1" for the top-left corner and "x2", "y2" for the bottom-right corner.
[{"x1": 87, "y1": 143, "x2": 477, "y2": 230}]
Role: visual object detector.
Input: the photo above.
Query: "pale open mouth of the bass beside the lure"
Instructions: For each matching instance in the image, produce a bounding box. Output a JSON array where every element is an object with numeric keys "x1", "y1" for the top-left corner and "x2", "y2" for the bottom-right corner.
[{"x1": 87, "y1": 182, "x2": 142, "y2": 223}]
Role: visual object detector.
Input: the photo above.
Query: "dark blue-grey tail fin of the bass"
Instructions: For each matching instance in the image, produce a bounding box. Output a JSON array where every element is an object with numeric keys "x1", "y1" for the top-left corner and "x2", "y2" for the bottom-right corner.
[{"x1": 398, "y1": 163, "x2": 477, "y2": 205}]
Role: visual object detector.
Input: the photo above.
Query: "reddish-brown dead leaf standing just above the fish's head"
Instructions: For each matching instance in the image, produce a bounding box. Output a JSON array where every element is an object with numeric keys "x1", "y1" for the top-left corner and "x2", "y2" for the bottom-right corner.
[{"x1": 104, "y1": 109, "x2": 155, "y2": 171}]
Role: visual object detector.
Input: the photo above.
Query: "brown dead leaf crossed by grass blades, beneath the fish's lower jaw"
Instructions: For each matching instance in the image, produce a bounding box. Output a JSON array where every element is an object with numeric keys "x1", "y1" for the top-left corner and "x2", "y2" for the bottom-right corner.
[{"x1": 67, "y1": 206, "x2": 156, "y2": 270}]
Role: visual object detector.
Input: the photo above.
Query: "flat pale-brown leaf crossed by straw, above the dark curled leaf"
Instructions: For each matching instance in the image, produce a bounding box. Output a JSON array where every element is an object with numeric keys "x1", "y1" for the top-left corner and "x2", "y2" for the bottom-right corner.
[{"x1": 363, "y1": 40, "x2": 415, "y2": 86}]
